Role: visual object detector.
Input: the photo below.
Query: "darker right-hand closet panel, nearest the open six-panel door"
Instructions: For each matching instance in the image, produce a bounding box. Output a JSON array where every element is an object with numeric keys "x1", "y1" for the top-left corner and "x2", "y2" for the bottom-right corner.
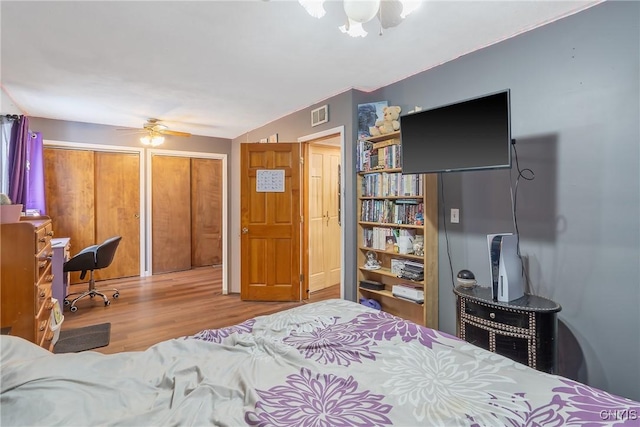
[{"x1": 191, "y1": 158, "x2": 222, "y2": 267}]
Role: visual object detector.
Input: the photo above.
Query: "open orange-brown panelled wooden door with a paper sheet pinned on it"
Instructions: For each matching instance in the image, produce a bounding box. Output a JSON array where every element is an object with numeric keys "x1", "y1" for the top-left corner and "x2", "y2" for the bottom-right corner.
[{"x1": 240, "y1": 143, "x2": 301, "y2": 301}]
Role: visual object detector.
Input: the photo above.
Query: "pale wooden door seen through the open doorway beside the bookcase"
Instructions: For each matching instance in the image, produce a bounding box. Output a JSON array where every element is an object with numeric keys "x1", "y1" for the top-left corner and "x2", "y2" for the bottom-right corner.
[{"x1": 308, "y1": 144, "x2": 341, "y2": 292}]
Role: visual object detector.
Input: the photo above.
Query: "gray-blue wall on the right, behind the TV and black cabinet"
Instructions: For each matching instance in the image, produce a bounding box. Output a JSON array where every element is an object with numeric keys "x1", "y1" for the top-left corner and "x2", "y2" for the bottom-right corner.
[{"x1": 377, "y1": 2, "x2": 640, "y2": 400}]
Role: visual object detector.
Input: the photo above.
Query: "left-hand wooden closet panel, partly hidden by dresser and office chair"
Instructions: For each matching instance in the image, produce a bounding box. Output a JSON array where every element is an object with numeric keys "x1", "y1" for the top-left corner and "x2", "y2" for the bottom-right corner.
[{"x1": 43, "y1": 148, "x2": 96, "y2": 283}]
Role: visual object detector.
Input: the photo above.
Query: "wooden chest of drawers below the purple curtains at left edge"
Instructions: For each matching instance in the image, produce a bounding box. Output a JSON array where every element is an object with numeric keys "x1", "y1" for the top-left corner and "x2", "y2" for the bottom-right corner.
[{"x1": 0, "y1": 217, "x2": 53, "y2": 351}]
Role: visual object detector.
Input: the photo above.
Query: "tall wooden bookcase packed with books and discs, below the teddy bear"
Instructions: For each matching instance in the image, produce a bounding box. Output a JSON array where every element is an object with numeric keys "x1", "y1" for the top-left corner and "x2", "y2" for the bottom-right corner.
[{"x1": 357, "y1": 132, "x2": 438, "y2": 329}]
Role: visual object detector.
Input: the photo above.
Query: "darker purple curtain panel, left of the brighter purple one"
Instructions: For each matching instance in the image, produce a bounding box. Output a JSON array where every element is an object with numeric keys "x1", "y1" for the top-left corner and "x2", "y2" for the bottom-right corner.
[{"x1": 8, "y1": 116, "x2": 31, "y2": 204}]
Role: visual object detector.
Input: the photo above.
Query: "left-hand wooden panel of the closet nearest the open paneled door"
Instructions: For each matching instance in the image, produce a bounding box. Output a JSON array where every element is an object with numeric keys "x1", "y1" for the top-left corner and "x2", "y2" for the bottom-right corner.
[{"x1": 151, "y1": 155, "x2": 191, "y2": 274}]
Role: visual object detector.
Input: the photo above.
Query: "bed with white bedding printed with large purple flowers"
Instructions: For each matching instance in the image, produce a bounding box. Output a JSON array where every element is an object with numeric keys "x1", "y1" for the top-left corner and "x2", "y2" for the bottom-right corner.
[{"x1": 0, "y1": 300, "x2": 640, "y2": 427}]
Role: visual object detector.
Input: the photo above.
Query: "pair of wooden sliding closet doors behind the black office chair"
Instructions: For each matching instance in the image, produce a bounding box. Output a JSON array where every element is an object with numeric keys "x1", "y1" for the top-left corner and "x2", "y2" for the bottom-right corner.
[{"x1": 44, "y1": 148, "x2": 140, "y2": 283}]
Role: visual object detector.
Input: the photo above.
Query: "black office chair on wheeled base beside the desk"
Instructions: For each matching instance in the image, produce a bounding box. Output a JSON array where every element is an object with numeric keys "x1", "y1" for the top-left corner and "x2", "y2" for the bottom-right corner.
[{"x1": 63, "y1": 236, "x2": 122, "y2": 312}]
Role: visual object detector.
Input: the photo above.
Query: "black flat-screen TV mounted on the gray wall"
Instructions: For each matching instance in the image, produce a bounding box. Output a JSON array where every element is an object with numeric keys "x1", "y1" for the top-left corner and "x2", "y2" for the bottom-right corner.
[{"x1": 400, "y1": 89, "x2": 511, "y2": 173}]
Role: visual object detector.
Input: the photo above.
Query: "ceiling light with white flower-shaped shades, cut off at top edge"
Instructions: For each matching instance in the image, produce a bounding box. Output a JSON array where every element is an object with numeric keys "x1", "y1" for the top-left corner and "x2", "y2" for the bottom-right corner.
[{"x1": 298, "y1": 0, "x2": 422, "y2": 37}]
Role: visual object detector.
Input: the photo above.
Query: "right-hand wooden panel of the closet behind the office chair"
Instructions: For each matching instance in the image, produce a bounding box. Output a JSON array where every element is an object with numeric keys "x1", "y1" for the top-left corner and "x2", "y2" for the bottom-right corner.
[{"x1": 95, "y1": 152, "x2": 140, "y2": 280}]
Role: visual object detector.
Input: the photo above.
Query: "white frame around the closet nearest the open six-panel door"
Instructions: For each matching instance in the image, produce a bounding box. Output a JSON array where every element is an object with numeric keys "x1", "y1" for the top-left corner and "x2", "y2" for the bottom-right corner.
[{"x1": 145, "y1": 148, "x2": 229, "y2": 295}]
